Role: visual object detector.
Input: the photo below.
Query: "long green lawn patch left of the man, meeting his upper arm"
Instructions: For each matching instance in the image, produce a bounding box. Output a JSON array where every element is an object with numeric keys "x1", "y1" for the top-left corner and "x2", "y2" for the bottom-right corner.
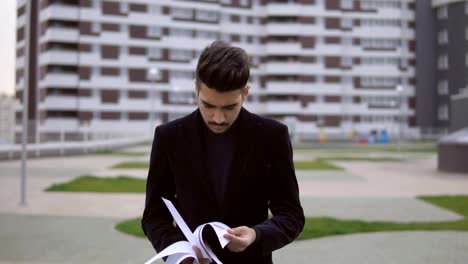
[{"x1": 46, "y1": 175, "x2": 146, "y2": 193}]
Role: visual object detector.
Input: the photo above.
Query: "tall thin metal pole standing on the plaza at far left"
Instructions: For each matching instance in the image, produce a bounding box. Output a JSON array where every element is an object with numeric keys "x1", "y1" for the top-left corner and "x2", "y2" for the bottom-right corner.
[{"x1": 20, "y1": 1, "x2": 31, "y2": 206}]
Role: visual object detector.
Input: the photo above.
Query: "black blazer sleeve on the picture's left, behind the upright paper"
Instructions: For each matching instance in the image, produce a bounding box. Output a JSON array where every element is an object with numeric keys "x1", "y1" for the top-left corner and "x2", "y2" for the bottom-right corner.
[{"x1": 141, "y1": 127, "x2": 185, "y2": 252}]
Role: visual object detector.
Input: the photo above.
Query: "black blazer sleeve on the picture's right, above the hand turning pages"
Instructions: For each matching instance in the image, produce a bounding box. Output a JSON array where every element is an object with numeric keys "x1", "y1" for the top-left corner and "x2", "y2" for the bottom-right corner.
[{"x1": 251, "y1": 126, "x2": 305, "y2": 255}]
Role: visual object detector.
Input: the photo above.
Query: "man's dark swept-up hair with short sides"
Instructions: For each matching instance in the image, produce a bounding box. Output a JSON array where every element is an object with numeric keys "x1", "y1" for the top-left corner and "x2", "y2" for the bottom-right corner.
[{"x1": 196, "y1": 41, "x2": 250, "y2": 92}]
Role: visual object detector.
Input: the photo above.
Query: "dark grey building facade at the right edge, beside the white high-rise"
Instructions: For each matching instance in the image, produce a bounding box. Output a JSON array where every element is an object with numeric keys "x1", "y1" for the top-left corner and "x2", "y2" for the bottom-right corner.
[{"x1": 416, "y1": 0, "x2": 468, "y2": 136}]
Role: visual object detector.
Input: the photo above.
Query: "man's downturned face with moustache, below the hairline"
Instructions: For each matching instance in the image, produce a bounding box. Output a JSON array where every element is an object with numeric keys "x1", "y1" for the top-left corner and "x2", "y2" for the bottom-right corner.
[{"x1": 197, "y1": 83, "x2": 249, "y2": 133}]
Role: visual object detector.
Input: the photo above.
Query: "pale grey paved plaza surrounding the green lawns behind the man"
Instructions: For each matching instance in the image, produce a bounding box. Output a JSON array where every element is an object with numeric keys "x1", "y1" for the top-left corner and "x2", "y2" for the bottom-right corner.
[{"x1": 0, "y1": 147, "x2": 468, "y2": 264}]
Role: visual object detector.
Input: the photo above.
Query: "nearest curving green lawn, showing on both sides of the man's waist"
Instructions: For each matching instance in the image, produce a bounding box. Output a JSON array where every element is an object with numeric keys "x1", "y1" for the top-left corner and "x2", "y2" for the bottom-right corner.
[{"x1": 116, "y1": 196, "x2": 468, "y2": 240}]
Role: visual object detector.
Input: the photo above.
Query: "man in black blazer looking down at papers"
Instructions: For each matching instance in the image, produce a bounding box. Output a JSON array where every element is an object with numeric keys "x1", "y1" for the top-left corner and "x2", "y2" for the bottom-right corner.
[{"x1": 142, "y1": 41, "x2": 304, "y2": 264}]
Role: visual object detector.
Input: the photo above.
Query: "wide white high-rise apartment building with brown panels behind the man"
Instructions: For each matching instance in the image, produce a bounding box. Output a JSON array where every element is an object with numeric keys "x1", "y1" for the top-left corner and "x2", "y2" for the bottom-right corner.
[{"x1": 17, "y1": 0, "x2": 417, "y2": 140}]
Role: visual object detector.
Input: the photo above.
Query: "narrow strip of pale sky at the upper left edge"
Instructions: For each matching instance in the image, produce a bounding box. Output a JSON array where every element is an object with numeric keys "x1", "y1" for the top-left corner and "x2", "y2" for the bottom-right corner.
[{"x1": 0, "y1": 0, "x2": 16, "y2": 94}]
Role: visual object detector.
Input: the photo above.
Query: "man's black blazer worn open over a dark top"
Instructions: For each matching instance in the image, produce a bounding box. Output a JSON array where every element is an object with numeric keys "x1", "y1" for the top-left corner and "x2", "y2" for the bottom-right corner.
[{"x1": 142, "y1": 108, "x2": 304, "y2": 264}]
